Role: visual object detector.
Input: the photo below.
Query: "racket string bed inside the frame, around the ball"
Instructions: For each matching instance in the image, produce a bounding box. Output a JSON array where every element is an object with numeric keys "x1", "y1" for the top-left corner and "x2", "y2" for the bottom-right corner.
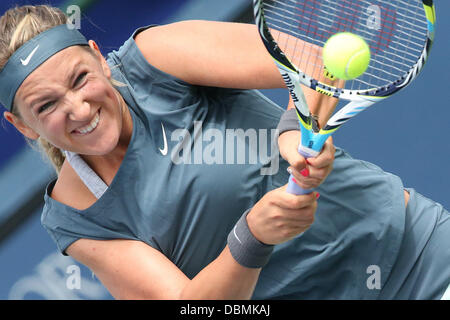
[{"x1": 264, "y1": 0, "x2": 428, "y2": 90}]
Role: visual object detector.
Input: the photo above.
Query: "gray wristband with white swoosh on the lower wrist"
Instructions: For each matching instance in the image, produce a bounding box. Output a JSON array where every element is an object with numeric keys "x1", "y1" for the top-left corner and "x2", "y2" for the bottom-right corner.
[{"x1": 228, "y1": 209, "x2": 274, "y2": 268}]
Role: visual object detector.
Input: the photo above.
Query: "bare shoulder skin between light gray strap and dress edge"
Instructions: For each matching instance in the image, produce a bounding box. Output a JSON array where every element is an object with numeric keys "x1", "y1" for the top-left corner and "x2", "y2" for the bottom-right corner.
[{"x1": 50, "y1": 160, "x2": 97, "y2": 210}]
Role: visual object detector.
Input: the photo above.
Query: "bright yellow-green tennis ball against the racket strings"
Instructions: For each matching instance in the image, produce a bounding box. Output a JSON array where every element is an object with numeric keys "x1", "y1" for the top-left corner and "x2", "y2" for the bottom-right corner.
[{"x1": 322, "y1": 32, "x2": 370, "y2": 80}]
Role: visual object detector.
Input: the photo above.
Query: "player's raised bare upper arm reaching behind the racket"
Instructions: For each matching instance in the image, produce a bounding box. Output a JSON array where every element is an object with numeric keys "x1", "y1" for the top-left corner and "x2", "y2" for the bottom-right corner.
[{"x1": 135, "y1": 20, "x2": 285, "y2": 89}]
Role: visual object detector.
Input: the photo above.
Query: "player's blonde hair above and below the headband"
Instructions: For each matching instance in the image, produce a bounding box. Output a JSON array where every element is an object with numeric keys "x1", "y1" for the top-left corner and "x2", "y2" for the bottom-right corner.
[{"x1": 0, "y1": 5, "x2": 125, "y2": 174}]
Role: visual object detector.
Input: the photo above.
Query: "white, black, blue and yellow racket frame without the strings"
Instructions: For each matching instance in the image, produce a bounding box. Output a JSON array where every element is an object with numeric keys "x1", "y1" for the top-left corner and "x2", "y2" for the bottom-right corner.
[{"x1": 253, "y1": 0, "x2": 436, "y2": 194}]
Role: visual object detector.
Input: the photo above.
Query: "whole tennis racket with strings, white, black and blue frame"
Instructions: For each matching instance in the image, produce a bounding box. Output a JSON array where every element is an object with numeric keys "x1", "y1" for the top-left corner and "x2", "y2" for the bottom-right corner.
[{"x1": 253, "y1": 0, "x2": 436, "y2": 194}]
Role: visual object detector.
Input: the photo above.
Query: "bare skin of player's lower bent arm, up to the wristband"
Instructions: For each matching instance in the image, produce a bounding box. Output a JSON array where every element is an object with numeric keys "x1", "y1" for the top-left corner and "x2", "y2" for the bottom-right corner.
[{"x1": 67, "y1": 239, "x2": 261, "y2": 300}]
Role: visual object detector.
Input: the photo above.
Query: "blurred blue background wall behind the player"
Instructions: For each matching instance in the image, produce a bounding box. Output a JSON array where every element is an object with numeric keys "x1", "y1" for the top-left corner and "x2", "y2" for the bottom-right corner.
[{"x1": 0, "y1": 0, "x2": 450, "y2": 299}]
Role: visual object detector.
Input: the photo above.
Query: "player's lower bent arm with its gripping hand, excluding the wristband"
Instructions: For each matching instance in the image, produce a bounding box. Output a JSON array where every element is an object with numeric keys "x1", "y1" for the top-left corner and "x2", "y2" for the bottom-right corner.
[{"x1": 66, "y1": 187, "x2": 317, "y2": 300}]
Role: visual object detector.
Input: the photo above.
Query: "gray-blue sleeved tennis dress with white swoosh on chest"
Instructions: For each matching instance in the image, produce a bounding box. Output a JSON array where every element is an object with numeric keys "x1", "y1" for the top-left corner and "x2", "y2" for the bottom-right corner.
[{"x1": 42, "y1": 28, "x2": 450, "y2": 299}]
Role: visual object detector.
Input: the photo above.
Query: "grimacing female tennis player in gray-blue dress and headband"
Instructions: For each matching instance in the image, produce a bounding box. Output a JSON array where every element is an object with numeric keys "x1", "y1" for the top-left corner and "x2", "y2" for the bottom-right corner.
[{"x1": 0, "y1": 6, "x2": 450, "y2": 299}]
